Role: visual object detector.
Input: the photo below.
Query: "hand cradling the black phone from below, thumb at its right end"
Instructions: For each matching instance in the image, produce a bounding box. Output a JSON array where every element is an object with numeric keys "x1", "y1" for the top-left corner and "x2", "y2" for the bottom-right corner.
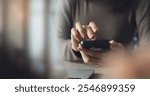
[{"x1": 78, "y1": 40, "x2": 125, "y2": 66}]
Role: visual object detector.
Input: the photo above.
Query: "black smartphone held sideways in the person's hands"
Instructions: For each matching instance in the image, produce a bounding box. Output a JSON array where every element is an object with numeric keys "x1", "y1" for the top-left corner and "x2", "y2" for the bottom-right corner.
[{"x1": 81, "y1": 40, "x2": 110, "y2": 51}]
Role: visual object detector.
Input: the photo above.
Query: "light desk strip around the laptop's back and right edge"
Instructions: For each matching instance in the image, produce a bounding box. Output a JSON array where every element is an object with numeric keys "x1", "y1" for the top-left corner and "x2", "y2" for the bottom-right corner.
[{"x1": 65, "y1": 61, "x2": 103, "y2": 79}]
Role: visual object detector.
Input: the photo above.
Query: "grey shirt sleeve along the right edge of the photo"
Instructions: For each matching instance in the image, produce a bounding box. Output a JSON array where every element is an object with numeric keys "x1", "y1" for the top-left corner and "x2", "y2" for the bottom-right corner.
[{"x1": 134, "y1": 0, "x2": 150, "y2": 47}]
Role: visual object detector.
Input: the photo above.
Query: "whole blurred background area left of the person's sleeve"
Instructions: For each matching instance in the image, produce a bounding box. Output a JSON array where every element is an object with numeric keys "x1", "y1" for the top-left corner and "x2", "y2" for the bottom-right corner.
[{"x1": 0, "y1": 0, "x2": 63, "y2": 79}]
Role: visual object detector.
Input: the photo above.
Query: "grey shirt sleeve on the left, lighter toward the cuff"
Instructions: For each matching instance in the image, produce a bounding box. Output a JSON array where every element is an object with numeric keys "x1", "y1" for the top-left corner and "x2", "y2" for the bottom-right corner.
[{"x1": 55, "y1": 0, "x2": 81, "y2": 61}]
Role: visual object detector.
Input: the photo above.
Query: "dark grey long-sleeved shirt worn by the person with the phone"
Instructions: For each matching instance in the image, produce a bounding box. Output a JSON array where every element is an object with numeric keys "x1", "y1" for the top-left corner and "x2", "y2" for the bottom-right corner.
[{"x1": 56, "y1": 0, "x2": 150, "y2": 61}]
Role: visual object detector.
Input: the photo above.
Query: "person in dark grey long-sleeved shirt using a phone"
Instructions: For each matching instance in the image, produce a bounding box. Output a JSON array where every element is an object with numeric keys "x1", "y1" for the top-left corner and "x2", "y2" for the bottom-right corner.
[{"x1": 55, "y1": 0, "x2": 150, "y2": 65}]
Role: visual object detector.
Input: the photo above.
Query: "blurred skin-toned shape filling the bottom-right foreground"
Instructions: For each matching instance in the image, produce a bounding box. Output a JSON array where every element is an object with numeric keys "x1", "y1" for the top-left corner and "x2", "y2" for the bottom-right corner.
[{"x1": 102, "y1": 47, "x2": 150, "y2": 79}]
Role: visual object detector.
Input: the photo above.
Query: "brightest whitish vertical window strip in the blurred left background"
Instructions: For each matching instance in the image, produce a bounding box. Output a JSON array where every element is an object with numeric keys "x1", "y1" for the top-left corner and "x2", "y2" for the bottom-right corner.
[{"x1": 28, "y1": 0, "x2": 45, "y2": 59}]
